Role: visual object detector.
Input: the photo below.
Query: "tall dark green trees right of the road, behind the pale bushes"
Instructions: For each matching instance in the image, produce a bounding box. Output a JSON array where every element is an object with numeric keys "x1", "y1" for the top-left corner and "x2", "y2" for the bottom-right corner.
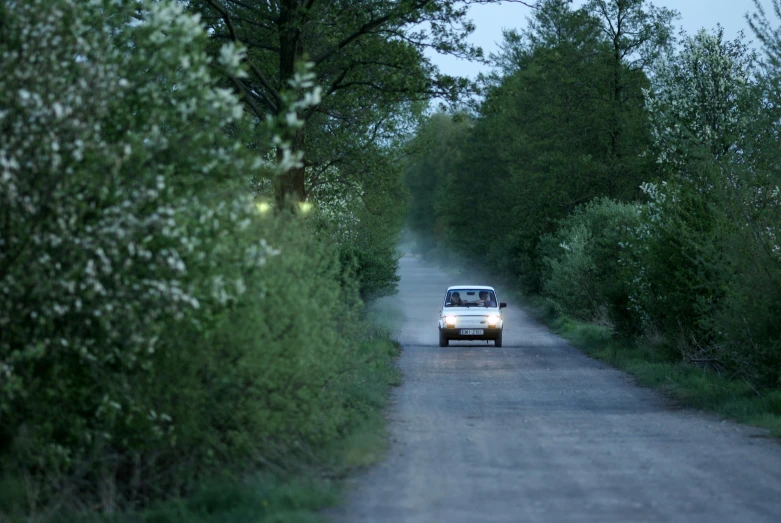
[{"x1": 408, "y1": 1, "x2": 666, "y2": 291}]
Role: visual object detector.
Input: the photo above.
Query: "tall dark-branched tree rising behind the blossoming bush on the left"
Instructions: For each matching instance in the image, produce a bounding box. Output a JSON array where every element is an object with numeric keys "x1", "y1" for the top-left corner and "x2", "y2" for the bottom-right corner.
[{"x1": 190, "y1": 0, "x2": 540, "y2": 202}]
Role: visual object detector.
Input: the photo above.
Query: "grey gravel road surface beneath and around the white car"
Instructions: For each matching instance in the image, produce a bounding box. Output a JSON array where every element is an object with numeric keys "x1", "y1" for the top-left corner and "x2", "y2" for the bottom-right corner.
[{"x1": 330, "y1": 256, "x2": 781, "y2": 523}]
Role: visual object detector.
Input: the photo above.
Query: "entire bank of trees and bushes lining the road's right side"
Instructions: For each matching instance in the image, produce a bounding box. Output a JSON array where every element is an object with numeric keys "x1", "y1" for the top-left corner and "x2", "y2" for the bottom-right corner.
[{"x1": 406, "y1": 0, "x2": 781, "y2": 401}]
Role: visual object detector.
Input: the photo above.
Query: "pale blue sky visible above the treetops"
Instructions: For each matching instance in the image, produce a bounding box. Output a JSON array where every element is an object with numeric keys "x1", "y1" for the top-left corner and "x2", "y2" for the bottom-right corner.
[{"x1": 429, "y1": 0, "x2": 781, "y2": 78}]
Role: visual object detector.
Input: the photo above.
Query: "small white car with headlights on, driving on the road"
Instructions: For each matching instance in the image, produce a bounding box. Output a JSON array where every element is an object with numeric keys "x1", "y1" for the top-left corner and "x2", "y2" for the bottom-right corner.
[{"x1": 439, "y1": 285, "x2": 507, "y2": 347}]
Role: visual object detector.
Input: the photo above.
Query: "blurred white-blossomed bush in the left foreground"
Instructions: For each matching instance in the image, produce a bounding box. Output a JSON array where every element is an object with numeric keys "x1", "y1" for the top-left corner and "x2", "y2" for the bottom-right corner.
[{"x1": 0, "y1": 0, "x2": 276, "y2": 488}]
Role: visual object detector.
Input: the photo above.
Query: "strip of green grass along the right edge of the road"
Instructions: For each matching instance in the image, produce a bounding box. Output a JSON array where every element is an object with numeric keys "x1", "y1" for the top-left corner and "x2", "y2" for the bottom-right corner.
[{"x1": 523, "y1": 297, "x2": 781, "y2": 437}]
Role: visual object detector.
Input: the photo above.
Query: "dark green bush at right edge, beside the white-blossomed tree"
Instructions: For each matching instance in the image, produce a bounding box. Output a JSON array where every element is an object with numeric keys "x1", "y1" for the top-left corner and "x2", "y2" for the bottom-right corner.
[{"x1": 703, "y1": 165, "x2": 781, "y2": 387}]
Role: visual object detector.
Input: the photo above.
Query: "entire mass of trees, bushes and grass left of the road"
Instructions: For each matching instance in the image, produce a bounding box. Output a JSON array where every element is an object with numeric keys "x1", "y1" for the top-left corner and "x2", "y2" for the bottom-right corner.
[{"x1": 0, "y1": 0, "x2": 464, "y2": 521}]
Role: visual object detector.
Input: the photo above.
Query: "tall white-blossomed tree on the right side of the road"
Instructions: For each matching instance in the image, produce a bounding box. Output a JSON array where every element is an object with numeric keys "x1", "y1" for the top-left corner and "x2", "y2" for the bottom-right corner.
[{"x1": 622, "y1": 28, "x2": 757, "y2": 349}]
